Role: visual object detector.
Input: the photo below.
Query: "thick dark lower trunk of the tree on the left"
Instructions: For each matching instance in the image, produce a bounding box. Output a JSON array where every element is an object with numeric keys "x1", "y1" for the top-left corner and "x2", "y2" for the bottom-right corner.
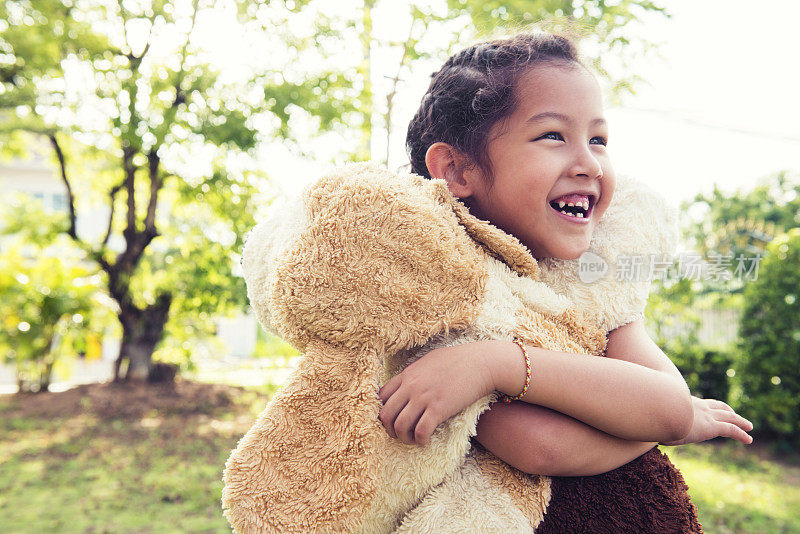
[{"x1": 114, "y1": 294, "x2": 172, "y2": 382}]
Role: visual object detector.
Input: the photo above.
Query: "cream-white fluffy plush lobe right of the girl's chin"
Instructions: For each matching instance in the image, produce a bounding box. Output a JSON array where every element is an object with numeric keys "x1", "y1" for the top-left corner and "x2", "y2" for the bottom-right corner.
[{"x1": 539, "y1": 177, "x2": 678, "y2": 331}]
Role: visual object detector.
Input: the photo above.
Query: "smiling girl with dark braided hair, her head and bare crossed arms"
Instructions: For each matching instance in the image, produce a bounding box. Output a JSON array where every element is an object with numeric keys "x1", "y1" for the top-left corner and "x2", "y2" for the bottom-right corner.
[{"x1": 379, "y1": 34, "x2": 752, "y2": 476}]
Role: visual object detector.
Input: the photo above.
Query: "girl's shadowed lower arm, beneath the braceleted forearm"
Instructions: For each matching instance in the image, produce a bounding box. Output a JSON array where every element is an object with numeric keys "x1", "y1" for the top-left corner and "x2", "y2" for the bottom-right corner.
[{"x1": 476, "y1": 402, "x2": 656, "y2": 476}]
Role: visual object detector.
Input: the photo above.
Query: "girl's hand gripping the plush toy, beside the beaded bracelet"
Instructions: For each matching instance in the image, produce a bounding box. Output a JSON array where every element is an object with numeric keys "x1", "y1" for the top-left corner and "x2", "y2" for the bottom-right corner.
[{"x1": 378, "y1": 341, "x2": 494, "y2": 445}]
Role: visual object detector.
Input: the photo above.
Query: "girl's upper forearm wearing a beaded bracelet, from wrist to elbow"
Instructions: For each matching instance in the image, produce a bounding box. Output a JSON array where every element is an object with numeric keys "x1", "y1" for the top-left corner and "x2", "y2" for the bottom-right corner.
[{"x1": 482, "y1": 340, "x2": 693, "y2": 442}]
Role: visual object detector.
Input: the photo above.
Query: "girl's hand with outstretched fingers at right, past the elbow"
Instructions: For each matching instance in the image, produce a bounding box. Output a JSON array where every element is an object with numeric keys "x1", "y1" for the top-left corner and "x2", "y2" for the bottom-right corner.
[{"x1": 662, "y1": 396, "x2": 753, "y2": 445}]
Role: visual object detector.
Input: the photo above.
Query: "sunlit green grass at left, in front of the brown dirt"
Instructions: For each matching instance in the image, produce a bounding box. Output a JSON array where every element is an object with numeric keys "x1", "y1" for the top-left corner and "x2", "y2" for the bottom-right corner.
[{"x1": 0, "y1": 392, "x2": 265, "y2": 534}]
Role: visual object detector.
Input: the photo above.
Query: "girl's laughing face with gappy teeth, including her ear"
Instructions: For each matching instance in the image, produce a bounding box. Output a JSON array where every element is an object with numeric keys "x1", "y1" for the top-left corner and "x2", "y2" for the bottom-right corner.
[{"x1": 464, "y1": 66, "x2": 615, "y2": 259}]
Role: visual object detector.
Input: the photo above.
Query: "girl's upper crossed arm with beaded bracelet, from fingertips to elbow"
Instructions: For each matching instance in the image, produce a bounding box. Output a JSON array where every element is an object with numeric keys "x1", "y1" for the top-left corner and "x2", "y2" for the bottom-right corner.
[{"x1": 379, "y1": 324, "x2": 693, "y2": 443}]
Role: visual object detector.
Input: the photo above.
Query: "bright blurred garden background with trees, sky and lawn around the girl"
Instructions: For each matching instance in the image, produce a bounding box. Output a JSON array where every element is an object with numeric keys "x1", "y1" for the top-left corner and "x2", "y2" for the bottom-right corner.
[{"x1": 0, "y1": 0, "x2": 800, "y2": 533}]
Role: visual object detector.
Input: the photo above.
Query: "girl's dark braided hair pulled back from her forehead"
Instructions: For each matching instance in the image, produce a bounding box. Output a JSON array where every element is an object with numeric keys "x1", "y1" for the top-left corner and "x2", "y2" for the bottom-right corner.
[{"x1": 406, "y1": 33, "x2": 582, "y2": 184}]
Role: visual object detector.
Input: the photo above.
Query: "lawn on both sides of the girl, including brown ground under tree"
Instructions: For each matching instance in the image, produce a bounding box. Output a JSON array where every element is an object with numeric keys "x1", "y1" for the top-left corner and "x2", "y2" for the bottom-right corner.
[{"x1": 0, "y1": 382, "x2": 800, "y2": 534}]
